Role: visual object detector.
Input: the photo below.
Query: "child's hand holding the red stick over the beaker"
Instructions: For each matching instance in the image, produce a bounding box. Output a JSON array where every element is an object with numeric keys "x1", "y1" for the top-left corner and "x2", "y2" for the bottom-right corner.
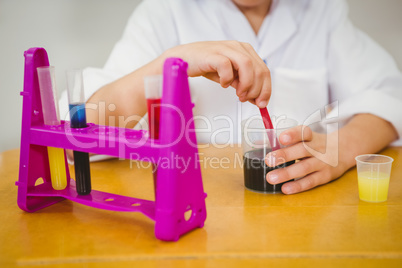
[{"x1": 163, "y1": 41, "x2": 271, "y2": 108}]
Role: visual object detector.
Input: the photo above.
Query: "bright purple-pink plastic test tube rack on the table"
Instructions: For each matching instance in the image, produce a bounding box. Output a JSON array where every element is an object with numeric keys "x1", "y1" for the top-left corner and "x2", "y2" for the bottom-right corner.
[{"x1": 16, "y1": 48, "x2": 206, "y2": 241}]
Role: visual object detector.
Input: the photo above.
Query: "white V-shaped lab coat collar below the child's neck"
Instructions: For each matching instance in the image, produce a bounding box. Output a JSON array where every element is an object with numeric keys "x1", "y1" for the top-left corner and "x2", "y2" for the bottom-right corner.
[{"x1": 217, "y1": 0, "x2": 297, "y2": 59}]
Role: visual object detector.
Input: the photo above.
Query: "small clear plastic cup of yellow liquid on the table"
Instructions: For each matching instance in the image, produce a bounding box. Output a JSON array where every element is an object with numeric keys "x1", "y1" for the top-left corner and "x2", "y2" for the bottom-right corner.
[{"x1": 355, "y1": 154, "x2": 394, "y2": 203}]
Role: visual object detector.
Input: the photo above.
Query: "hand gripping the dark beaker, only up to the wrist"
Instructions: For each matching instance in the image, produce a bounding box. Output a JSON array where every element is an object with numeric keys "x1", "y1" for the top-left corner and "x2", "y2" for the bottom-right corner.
[{"x1": 265, "y1": 126, "x2": 349, "y2": 194}]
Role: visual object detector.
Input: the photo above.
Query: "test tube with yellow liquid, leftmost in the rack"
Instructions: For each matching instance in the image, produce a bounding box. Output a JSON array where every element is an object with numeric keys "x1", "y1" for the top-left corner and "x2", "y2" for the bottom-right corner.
[{"x1": 36, "y1": 66, "x2": 67, "y2": 190}]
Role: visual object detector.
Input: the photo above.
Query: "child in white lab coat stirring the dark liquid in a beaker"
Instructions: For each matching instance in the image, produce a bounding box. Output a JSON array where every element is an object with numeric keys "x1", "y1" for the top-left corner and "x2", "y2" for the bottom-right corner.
[{"x1": 58, "y1": 0, "x2": 402, "y2": 194}]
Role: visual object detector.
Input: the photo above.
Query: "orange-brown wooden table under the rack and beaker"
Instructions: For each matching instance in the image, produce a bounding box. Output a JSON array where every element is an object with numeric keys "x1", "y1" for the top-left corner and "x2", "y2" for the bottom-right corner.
[{"x1": 0, "y1": 148, "x2": 402, "y2": 268}]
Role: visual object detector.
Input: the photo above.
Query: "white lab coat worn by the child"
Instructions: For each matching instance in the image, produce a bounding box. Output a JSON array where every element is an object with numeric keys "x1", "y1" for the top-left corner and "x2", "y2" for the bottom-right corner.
[{"x1": 60, "y1": 0, "x2": 402, "y2": 145}]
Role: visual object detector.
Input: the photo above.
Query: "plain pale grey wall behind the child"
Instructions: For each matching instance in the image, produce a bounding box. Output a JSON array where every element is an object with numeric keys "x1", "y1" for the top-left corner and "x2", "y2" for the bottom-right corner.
[{"x1": 0, "y1": 0, "x2": 402, "y2": 152}]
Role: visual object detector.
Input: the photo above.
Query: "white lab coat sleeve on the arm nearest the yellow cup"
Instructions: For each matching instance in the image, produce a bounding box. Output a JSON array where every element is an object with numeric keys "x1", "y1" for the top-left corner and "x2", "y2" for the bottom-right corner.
[{"x1": 328, "y1": 0, "x2": 402, "y2": 145}]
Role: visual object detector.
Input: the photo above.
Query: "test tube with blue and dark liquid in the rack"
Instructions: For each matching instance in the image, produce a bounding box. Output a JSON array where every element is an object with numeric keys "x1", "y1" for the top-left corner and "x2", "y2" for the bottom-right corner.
[{"x1": 67, "y1": 70, "x2": 91, "y2": 195}]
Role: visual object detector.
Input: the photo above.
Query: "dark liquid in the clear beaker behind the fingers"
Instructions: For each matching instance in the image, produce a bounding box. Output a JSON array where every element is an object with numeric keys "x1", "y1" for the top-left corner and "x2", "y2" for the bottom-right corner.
[{"x1": 243, "y1": 149, "x2": 295, "y2": 193}]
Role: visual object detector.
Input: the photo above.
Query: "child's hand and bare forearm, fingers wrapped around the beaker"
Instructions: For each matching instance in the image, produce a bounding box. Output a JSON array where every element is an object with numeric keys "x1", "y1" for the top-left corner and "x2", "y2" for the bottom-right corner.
[{"x1": 265, "y1": 114, "x2": 398, "y2": 194}]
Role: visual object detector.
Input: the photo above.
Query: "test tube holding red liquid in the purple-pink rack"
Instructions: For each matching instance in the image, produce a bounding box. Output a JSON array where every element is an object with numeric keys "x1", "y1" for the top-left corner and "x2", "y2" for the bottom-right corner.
[{"x1": 144, "y1": 75, "x2": 162, "y2": 196}]
